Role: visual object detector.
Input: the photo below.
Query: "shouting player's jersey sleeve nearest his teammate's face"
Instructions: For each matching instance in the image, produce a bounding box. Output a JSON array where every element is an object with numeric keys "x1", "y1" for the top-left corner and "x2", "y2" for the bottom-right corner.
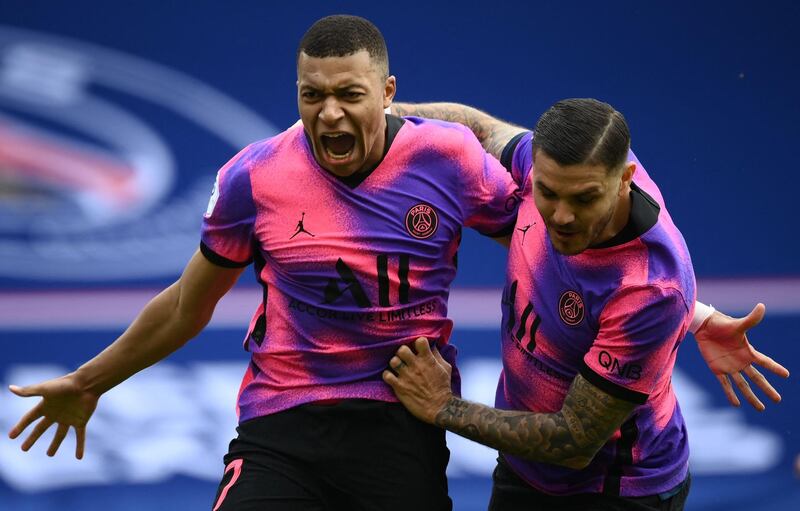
[{"x1": 462, "y1": 128, "x2": 522, "y2": 237}]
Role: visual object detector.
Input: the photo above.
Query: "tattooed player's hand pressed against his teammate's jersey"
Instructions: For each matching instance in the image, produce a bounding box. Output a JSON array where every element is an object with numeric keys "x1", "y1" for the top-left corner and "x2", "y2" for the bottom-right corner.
[{"x1": 383, "y1": 337, "x2": 453, "y2": 424}]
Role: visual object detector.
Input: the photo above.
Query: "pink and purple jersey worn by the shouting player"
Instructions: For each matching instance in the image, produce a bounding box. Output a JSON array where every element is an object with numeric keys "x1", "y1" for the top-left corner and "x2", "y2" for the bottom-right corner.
[{"x1": 201, "y1": 116, "x2": 519, "y2": 422}]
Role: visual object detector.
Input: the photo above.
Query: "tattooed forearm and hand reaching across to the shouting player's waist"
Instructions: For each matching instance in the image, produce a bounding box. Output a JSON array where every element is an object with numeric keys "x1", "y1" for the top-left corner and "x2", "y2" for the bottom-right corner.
[{"x1": 383, "y1": 338, "x2": 636, "y2": 469}]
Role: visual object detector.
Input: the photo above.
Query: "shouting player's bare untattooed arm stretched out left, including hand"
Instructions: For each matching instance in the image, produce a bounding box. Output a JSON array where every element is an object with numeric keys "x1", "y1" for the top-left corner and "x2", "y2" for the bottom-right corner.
[{"x1": 9, "y1": 251, "x2": 242, "y2": 459}]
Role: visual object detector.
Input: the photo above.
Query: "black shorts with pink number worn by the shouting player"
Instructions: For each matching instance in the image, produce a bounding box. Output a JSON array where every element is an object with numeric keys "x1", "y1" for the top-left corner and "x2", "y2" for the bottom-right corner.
[{"x1": 212, "y1": 400, "x2": 453, "y2": 511}]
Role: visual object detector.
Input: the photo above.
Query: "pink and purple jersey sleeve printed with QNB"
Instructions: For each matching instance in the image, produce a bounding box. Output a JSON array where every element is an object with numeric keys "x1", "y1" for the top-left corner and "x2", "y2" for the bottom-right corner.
[{"x1": 580, "y1": 285, "x2": 691, "y2": 404}]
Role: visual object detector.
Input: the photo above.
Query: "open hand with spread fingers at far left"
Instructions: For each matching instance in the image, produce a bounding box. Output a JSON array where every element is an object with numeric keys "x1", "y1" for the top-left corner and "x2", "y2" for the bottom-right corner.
[{"x1": 8, "y1": 374, "x2": 99, "y2": 459}]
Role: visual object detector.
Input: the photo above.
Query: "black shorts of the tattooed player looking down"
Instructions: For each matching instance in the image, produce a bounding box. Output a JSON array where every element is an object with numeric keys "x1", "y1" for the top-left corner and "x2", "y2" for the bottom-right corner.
[{"x1": 489, "y1": 456, "x2": 691, "y2": 511}]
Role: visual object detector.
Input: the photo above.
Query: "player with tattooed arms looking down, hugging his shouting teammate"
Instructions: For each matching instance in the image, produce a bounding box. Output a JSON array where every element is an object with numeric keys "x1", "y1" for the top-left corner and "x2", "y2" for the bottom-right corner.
[{"x1": 384, "y1": 99, "x2": 788, "y2": 511}]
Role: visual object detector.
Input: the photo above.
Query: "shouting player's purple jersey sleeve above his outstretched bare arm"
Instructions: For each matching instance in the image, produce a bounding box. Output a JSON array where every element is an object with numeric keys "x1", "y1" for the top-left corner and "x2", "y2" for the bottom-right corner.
[{"x1": 200, "y1": 146, "x2": 256, "y2": 268}]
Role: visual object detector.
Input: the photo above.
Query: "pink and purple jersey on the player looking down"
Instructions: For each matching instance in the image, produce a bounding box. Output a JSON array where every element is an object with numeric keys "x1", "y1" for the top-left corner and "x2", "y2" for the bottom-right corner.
[{"x1": 496, "y1": 133, "x2": 695, "y2": 496}]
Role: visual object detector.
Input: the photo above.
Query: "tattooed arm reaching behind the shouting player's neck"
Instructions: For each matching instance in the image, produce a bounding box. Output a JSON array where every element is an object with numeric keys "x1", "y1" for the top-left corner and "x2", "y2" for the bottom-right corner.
[{"x1": 392, "y1": 103, "x2": 528, "y2": 160}]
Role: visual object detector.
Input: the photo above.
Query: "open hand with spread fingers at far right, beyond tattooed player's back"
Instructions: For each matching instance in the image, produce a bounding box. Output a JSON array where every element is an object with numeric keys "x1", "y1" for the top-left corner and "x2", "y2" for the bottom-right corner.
[{"x1": 694, "y1": 303, "x2": 789, "y2": 411}]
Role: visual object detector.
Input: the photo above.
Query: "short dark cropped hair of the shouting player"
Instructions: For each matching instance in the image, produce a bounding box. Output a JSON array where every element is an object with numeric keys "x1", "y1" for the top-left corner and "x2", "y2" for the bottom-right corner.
[{"x1": 297, "y1": 14, "x2": 389, "y2": 76}]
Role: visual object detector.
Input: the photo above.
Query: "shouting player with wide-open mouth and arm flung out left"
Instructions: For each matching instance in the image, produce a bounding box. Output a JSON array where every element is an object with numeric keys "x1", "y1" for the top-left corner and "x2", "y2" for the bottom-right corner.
[{"x1": 4, "y1": 16, "x2": 780, "y2": 511}]
